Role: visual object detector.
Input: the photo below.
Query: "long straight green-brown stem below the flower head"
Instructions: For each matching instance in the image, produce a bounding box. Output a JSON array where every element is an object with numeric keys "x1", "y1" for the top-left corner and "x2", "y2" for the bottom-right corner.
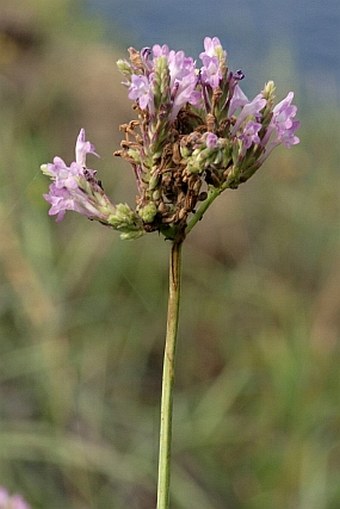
[{"x1": 157, "y1": 241, "x2": 182, "y2": 509}]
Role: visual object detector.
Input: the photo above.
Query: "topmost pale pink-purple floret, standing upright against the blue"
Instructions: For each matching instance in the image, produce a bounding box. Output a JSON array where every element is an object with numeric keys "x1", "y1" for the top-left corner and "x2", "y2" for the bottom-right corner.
[{"x1": 200, "y1": 37, "x2": 226, "y2": 89}]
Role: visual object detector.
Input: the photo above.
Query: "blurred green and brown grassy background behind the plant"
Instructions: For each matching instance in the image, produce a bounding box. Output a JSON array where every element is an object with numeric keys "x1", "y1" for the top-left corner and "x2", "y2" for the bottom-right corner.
[{"x1": 0, "y1": 0, "x2": 340, "y2": 509}]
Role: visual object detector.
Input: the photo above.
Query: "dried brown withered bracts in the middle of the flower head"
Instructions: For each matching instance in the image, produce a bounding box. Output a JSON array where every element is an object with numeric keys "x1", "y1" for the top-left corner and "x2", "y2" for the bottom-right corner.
[{"x1": 114, "y1": 112, "x2": 211, "y2": 240}]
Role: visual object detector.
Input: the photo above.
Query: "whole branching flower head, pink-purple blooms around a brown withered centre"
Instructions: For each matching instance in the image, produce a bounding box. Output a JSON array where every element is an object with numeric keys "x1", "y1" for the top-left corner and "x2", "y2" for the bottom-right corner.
[{"x1": 42, "y1": 37, "x2": 299, "y2": 239}]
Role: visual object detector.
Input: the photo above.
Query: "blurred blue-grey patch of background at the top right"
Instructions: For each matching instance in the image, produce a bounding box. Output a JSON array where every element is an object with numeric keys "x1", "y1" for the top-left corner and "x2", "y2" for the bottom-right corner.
[{"x1": 86, "y1": 0, "x2": 340, "y2": 99}]
